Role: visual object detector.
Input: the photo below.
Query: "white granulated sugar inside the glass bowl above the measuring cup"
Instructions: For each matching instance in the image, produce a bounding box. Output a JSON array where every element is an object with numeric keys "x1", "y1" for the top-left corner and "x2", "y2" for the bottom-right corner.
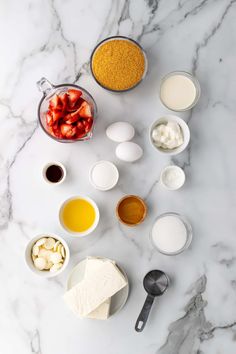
[{"x1": 151, "y1": 215, "x2": 188, "y2": 254}]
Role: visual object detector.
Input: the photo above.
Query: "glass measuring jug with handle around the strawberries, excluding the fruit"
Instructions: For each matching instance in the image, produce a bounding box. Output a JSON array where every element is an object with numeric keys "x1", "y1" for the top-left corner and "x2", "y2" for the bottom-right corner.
[{"x1": 37, "y1": 77, "x2": 97, "y2": 143}]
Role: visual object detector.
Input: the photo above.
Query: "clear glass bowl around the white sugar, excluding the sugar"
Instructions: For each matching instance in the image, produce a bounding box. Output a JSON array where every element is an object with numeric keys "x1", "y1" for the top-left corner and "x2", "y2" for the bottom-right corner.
[{"x1": 149, "y1": 212, "x2": 193, "y2": 256}]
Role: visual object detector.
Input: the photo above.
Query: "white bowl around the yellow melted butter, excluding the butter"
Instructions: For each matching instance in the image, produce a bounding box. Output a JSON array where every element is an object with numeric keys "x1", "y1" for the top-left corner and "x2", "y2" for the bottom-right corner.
[{"x1": 59, "y1": 195, "x2": 100, "y2": 238}]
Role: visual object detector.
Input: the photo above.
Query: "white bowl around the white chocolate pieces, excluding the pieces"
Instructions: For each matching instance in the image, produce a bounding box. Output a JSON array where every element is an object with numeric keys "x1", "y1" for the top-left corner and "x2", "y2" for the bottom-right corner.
[{"x1": 25, "y1": 233, "x2": 70, "y2": 278}]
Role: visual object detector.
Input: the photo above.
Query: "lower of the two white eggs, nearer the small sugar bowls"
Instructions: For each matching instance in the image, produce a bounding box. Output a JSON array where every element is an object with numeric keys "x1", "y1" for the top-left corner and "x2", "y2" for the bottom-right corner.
[{"x1": 116, "y1": 141, "x2": 143, "y2": 162}]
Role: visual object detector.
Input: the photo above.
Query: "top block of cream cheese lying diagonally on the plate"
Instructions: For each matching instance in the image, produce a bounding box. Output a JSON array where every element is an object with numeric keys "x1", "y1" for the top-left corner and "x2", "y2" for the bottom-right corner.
[{"x1": 64, "y1": 262, "x2": 127, "y2": 317}]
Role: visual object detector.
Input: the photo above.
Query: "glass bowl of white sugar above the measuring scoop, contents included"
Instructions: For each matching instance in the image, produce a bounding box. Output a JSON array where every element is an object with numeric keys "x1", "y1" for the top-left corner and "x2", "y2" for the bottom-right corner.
[{"x1": 150, "y1": 213, "x2": 192, "y2": 256}]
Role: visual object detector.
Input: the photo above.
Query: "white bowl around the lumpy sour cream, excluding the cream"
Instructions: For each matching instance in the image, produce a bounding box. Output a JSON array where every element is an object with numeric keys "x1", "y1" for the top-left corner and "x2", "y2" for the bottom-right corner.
[{"x1": 149, "y1": 115, "x2": 190, "y2": 155}]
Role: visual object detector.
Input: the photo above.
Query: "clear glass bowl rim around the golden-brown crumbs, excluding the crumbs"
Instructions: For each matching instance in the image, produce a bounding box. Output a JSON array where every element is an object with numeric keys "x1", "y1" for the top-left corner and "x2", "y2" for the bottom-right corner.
[{"x1": 90, "y1": 36, "x2": 148, "y2": 92}]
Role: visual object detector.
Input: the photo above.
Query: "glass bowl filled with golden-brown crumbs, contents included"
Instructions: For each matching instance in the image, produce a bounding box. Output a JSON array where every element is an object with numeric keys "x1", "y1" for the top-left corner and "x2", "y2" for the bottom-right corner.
[{"x1": 90, "y1": 36, "x2": 147, "y2": 92}]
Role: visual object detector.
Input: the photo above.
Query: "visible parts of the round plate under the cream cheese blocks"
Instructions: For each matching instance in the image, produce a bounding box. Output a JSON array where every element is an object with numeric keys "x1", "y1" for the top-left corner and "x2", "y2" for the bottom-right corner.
[{"x1": 66, "y1": 257, "x2": 129, "y2": 317}]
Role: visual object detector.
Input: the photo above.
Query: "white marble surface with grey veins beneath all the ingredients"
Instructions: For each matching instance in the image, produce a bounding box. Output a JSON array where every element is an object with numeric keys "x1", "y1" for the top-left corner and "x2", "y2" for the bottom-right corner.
[{"x1": 0, "y1": 0, "x2": 236, "y2": 354}]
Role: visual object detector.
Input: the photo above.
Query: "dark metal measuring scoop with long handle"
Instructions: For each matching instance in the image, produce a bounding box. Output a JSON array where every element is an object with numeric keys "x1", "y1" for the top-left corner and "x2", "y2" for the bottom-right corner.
[{"x1": 135, "y1": 270, "x2": 169, "y2": 332}]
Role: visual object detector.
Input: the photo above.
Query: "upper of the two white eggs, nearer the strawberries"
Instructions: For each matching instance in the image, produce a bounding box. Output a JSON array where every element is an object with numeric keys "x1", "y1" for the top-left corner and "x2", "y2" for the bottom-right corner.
[{"x1": 106, "y1": 122, "x2": 135, "y2": 143}]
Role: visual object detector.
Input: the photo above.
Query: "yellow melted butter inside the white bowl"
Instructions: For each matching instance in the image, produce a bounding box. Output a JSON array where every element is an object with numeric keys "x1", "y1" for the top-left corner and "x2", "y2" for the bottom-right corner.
[{"x1": 61, "y1": 199, "x2": 96, "y2": 232}]
